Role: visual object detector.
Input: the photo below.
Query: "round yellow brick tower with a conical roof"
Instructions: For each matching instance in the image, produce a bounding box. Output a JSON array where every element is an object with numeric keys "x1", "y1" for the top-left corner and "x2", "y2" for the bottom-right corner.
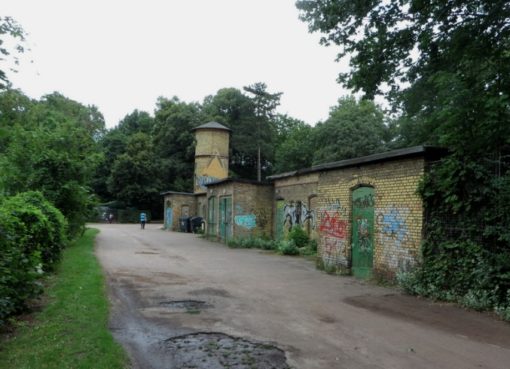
[{"x1": 194, "y1": 122, "x2": 231, "y2": 193}]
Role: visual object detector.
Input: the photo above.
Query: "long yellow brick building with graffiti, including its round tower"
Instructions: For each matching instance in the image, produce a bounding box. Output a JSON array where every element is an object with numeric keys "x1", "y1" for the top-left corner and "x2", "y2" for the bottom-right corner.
[{"x1": 164, "y1": 122, "x2": 444, "y2": 279}]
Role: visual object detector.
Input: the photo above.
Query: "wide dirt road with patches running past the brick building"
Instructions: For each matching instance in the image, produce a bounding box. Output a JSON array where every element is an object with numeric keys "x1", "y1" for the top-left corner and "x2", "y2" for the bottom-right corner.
[{"x1": 93, "y1": 224, "x2": 510, "y2": 369}]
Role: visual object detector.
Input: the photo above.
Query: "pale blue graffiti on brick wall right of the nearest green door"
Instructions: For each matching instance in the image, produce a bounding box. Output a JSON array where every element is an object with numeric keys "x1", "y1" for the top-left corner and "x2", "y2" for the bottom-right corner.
[{"x1": 376, "y1": 206, "x2": 416, "y2": 270}]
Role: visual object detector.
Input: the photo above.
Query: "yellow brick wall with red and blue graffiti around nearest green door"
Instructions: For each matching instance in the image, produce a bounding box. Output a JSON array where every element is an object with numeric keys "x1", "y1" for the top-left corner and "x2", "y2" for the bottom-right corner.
[{"x1": 317, "y1": 158, "x2": 424, "y2": 278}]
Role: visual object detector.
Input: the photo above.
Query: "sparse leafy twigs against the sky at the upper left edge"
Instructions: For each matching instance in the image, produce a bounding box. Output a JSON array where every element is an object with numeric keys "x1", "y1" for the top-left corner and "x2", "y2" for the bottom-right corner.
[{"x1": 0, "y1": 17, "x2": 25, "y2": 91}]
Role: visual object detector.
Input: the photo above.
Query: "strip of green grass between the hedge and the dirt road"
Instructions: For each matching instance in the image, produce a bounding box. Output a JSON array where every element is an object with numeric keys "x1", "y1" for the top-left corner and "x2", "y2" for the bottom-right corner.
[{"x1": 0, "y1": 229, "x2": 128, "y2": 369}]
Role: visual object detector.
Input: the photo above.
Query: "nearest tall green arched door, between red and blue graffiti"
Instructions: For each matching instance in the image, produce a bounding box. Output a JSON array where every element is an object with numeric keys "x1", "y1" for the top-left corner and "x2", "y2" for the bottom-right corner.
[{"x1": 352, "y1": 187, "x2": 374, "y2": 278}]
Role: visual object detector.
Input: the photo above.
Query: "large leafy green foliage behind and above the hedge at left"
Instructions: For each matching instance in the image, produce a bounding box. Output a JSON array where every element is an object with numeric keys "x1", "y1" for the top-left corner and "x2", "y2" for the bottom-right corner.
[{"x1": 0, "y1": 91, "x2": 104, "y2": 236}]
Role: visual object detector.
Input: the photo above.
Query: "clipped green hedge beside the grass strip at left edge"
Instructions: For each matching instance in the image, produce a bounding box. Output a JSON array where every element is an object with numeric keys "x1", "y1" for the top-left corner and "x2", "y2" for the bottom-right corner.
[{"x1": 0, "y1": 192, "x2": 66, "y2": 325}]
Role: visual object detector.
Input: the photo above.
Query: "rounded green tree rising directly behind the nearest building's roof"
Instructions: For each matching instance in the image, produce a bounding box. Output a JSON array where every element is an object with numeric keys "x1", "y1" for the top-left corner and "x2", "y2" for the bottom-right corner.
[{"x1": 313, "y1": 97, "x2": 387, "y2": 164}]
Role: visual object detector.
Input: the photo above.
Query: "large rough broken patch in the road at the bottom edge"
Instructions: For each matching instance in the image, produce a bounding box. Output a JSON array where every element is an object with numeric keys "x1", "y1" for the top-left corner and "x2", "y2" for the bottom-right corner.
[{"x1": 160, "y1": 332, "x2": 290, "y2": 369}]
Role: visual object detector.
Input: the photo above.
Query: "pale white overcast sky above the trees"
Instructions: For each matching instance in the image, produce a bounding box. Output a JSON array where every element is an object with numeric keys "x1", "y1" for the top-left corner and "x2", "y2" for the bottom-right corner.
[{"x1": 2, "y1": 0, "x2": 348, "y2": 127}]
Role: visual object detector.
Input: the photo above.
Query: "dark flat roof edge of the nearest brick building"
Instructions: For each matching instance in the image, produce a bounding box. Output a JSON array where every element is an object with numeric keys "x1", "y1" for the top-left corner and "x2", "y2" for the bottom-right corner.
[{"x1": 267, "y1": 146, "x2": 448, "y2": 180}]
